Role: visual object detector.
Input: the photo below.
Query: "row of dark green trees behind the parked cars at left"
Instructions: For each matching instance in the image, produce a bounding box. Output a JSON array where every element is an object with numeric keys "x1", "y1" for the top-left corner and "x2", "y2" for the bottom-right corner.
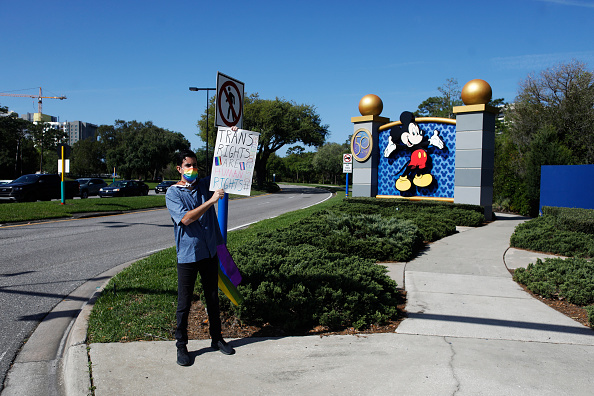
[{"x1": 0, "y1": 113, "x2": 190, "y2": 180}]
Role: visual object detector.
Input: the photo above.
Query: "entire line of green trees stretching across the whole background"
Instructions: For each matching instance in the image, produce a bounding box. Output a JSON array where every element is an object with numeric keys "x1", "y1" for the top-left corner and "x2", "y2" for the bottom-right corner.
[{"x1": 0, "y1": 60, "x2": 594, "y2": 216}]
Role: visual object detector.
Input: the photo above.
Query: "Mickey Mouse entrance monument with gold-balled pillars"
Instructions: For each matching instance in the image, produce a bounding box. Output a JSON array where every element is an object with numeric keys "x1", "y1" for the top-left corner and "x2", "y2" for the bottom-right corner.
[{"x1": 351, "y1": 79, "x2": 499, "y2": 220}]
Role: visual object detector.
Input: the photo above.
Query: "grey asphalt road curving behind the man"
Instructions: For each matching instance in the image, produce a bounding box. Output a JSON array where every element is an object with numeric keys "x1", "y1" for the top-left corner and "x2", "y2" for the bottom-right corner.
[{"x1": 0, "y1": 186, "x2": 330, "y2": 391}]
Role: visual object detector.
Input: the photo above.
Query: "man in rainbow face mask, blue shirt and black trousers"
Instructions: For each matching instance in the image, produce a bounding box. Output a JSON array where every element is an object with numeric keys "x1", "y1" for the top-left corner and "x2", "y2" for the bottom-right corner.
[{"x1": 165, "y1": 150, "x2": 235, "y2": 366}]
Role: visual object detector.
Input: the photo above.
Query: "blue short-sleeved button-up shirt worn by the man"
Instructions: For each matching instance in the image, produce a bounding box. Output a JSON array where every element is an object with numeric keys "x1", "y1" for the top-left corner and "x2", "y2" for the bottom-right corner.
[{"x1": 165, "y1": 177, "x2": 224, "y2": 263}]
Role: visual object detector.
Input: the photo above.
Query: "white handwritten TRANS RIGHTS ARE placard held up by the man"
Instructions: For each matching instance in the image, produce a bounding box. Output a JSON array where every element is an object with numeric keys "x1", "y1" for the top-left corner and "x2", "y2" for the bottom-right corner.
[{"x1": 210, "y1": 127, "x2": 260, "y2": 196}]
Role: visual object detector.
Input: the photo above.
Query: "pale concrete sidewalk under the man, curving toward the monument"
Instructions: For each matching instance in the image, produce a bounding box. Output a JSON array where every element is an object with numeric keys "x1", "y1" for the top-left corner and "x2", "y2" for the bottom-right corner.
[{"x1": 65, "y1": 215, "x2": 594, "y2": 396}]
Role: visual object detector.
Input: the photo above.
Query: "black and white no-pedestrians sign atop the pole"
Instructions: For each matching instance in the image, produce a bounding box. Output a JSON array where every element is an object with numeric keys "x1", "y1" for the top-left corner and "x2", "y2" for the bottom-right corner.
[{"x1": 215, "y1": 72, "x2": 243, "y2": 128}]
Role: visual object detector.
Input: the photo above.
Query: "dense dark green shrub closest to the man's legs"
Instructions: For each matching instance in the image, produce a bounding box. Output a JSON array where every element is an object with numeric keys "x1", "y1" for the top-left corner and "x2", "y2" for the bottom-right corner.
[{"x1": 233, "y1": 240, "x2": 398, "y2": 332}]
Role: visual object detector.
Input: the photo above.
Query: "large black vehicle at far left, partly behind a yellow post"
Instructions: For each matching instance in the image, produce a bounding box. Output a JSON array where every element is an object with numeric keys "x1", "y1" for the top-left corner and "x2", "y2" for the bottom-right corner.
[{"x1": 0, "y1": 174, "x2": 79, "y2": 202}]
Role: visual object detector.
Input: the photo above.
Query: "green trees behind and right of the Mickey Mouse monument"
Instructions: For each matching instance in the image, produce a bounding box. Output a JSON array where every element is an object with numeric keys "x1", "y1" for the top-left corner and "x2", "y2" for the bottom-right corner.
[{"x1": 415, "y1": 60, "x2": 594, "y2": 217}]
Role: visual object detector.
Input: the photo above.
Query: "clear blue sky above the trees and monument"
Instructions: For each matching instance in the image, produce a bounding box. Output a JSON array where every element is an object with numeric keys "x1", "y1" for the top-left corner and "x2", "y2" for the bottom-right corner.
[{"x1": 0, "y1": 0, "x2": 594, "y2": 155}]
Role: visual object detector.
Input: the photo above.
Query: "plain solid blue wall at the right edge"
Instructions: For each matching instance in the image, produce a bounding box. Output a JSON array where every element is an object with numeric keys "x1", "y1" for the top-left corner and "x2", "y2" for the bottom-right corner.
[{"x1": 540, "y1": 165, "x2": 594, "y2": 211}]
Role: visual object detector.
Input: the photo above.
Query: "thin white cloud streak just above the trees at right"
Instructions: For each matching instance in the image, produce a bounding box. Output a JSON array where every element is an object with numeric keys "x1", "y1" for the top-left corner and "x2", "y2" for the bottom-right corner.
[{"x1": 491, "y1": 51, "x2": 594, "y2": 70}]
